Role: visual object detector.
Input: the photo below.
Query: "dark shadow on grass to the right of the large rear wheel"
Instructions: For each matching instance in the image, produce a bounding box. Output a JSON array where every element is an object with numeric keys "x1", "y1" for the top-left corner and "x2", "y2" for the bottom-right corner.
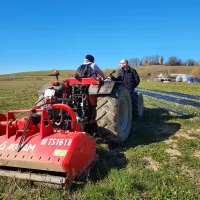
[{"x1": 124, "y1": 108, "x2": 184, "y2": 148}]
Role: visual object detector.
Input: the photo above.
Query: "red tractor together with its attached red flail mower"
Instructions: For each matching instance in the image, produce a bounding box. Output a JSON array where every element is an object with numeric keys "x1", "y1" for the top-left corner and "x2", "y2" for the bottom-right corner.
[{"x1": 0, "y1": 72, "x2": 143, "y2": 188}]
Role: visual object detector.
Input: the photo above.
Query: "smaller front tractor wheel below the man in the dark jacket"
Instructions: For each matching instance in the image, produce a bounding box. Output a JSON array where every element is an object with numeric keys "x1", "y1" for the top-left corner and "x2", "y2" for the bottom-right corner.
[{"x1": 132, "y1": 92, "x2": 144, "y2": 118}]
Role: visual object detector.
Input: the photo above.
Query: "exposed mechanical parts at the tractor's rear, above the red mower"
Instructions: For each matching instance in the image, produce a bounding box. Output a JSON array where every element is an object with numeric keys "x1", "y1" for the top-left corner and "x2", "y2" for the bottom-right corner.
[{"x1": 42, "y1": 80, "x2": 88, "y2": 130}]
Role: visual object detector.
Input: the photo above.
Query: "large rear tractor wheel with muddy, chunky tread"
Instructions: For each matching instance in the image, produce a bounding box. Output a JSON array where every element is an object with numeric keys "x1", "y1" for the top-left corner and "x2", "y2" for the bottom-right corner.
[{"x1": 96, "y1": 84, "x2": 132, "y2": 143}]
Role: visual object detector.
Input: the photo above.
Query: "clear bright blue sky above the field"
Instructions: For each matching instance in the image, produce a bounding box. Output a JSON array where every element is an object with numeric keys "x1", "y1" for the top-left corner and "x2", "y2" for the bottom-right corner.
[{"x1": 0, "y1": 0, "x2": 200, "y2": 74}]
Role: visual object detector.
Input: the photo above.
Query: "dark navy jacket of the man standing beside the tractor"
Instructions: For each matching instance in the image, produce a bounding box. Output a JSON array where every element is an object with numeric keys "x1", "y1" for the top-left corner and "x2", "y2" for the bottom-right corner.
[{"x1": 112, "y1": 66, "x2": 140, "y2": 90}]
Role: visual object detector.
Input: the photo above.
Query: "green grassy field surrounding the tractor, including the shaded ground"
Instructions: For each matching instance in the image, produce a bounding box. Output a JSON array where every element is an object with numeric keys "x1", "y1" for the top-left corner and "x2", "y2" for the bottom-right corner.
[{"x1": 0, "y1": 71, "x2": 200, "y2": 200}]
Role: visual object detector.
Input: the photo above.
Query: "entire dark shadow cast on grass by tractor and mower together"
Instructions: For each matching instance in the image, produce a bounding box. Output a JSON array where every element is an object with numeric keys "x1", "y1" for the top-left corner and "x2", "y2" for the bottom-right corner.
[{"x1": 72, "y1": 108, "x2": 188, "y2": 191}]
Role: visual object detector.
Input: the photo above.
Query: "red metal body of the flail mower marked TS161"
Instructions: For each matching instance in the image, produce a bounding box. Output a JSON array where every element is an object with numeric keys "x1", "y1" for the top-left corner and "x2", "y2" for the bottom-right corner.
[{"x1": 0, "y1": 104, "x2": 98, "y2": 187}]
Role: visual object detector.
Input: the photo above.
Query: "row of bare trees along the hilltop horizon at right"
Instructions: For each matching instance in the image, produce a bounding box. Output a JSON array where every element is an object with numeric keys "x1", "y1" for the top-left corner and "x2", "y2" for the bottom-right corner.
[{"x1": 129, "y1": 55, "x2": 200, "y2": 66}]
